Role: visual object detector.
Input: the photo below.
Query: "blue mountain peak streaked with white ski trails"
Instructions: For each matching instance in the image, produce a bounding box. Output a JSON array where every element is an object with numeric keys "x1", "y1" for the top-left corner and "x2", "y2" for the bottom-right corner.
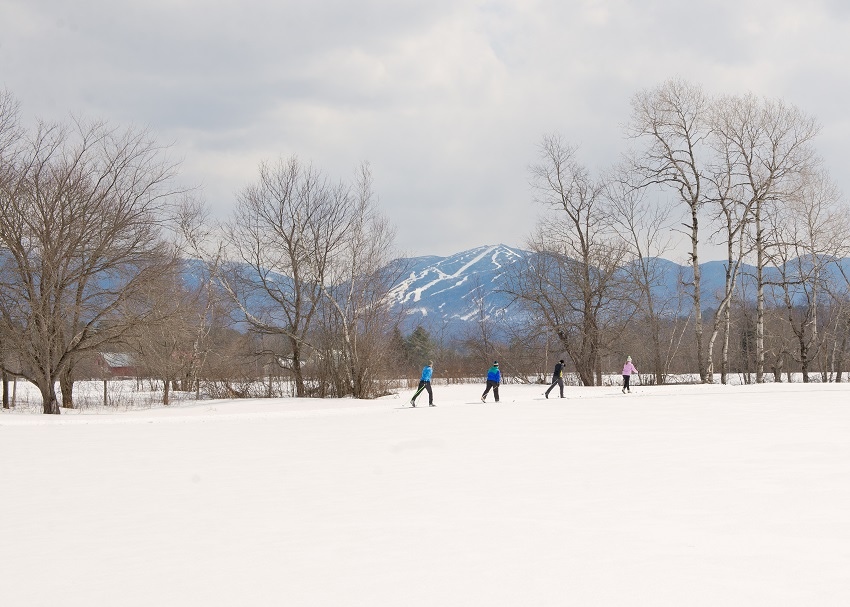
[{"x1": 390, "y1": 244, "x2": 530, "y2": 331}]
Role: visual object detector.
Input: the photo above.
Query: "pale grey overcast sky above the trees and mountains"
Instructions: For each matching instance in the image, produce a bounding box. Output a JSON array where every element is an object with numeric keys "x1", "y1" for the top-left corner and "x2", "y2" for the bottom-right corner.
[{"x1": 0, "y1": 0, "x2": 850, "y2": 259}]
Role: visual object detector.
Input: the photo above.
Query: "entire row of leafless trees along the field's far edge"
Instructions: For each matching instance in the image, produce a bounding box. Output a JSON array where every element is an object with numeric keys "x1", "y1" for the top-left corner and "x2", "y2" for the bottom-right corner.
[{"x1": 0, "y1": 80, "x2": 850, "y2": 413}]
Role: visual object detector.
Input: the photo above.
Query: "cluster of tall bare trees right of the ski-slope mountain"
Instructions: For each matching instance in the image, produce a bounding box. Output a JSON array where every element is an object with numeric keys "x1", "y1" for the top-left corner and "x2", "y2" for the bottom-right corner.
[{"x1": 507, "y1": 79, "x2": 850, "y2": 385}]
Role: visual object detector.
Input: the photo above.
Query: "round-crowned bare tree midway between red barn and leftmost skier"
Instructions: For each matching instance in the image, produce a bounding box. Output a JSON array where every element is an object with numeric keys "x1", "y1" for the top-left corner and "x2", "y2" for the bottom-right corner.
[{"x1": 219, "y1": 156, "x2": 391, "y2": 396}]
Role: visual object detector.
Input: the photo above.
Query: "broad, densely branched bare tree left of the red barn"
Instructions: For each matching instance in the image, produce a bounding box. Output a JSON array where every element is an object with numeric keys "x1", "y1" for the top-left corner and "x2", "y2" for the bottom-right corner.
[{"x1": 0, "y1": 120, "x2": 181, "y2": 413}]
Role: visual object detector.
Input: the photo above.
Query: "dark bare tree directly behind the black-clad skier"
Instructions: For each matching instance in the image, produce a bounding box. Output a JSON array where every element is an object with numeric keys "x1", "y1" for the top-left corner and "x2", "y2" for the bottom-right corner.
[{"x1": 505, "y1": 135, "x2": 625, "y2": 385}]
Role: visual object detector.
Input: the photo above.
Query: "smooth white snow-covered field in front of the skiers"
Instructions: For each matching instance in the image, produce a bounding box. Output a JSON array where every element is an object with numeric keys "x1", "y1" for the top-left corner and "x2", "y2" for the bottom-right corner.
[{"x1": 0, "y1": 384, "x2": 850, "y2": 607}]
